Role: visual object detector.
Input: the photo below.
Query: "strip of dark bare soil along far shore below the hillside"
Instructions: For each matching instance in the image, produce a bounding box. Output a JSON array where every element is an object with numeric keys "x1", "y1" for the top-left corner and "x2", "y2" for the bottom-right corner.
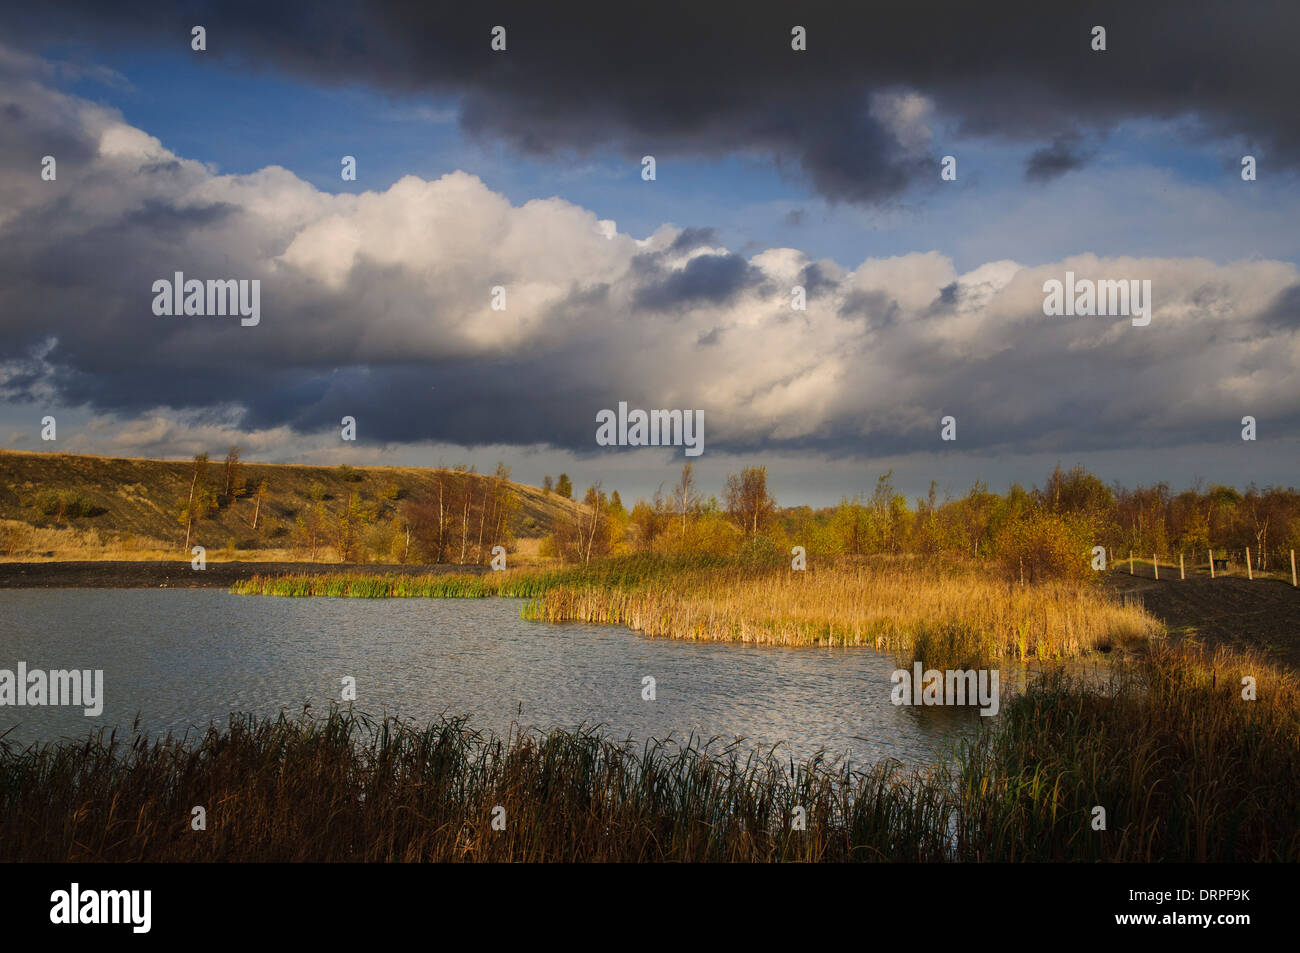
[{"x1": 0, "y1": 559, "x2": 488, "y2": 589}]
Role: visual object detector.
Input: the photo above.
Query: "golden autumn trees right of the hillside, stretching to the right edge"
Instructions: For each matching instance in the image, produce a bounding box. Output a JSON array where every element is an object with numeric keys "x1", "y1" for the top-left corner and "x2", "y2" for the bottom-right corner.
[{"x1": 545, "y1": 463, "x2": 1300, "y2": 581}]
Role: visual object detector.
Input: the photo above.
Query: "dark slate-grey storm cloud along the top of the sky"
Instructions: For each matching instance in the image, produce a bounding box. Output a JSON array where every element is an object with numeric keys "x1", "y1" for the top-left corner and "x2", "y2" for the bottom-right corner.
[{"x1": 9, "y1": 0, "x2": 1300, "y2": 202}]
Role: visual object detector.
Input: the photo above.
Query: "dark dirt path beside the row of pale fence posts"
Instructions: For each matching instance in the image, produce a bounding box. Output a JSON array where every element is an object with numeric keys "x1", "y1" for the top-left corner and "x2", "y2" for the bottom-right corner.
[{"x1": 1108, "y1": 569, "x2": 1300, "y2": 670}]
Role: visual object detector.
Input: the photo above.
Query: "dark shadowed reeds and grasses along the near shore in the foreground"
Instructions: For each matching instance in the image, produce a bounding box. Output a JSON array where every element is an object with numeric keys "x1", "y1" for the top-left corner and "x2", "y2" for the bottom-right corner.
[{"x1": 0, "y1": 647, "x2": 1300, "y2": 861}]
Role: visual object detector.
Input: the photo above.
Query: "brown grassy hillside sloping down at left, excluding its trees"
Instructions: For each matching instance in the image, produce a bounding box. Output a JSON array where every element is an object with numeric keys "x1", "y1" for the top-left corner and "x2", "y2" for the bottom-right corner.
[{"x1": 0, "y1": 450, "x2": 582, "y2": 562}]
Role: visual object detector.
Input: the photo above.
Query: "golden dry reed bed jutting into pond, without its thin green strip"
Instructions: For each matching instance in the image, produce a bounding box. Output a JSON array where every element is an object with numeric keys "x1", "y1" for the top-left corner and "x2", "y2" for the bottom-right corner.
[{"x1": 525, "y1": 566, "x2": 1164, "y2": 668}]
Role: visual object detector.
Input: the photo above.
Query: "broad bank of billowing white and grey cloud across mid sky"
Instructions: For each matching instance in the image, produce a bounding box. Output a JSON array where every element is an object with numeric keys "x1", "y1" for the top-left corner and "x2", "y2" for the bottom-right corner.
[{"x1": 0, "y1": 43, "x2": 1300, "y2": 465}]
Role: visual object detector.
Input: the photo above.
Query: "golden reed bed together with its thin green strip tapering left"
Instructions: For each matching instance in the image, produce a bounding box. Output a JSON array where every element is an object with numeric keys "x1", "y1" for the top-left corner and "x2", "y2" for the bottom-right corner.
[{"x1": 233, "y1": 558, "x2": 1161, "y2": 667}]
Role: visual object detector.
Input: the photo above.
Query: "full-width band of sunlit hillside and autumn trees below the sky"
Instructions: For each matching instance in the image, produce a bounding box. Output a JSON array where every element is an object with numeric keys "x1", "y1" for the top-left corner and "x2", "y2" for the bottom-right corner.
[{"x1": 0, "y1": 447, "x2": 1300, "y2": 582}]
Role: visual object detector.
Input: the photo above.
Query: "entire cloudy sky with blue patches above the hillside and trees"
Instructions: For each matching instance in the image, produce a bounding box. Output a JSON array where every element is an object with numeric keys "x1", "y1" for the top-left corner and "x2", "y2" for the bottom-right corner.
[{"x1": 0, "y1": 0, "x2": 1300, "y2": 506}]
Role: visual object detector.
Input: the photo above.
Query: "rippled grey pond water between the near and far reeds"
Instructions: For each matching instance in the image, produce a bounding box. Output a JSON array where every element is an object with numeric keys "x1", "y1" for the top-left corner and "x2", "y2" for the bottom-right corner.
[{"x1": 0, "y1": 589, "x2": 979, "y2": 764}]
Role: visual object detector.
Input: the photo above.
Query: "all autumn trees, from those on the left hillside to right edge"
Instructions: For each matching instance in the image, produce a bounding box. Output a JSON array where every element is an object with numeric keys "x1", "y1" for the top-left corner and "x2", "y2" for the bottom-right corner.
[{"x1": 174, "y1": 447, "x2": 1300, "y2": 581}]
